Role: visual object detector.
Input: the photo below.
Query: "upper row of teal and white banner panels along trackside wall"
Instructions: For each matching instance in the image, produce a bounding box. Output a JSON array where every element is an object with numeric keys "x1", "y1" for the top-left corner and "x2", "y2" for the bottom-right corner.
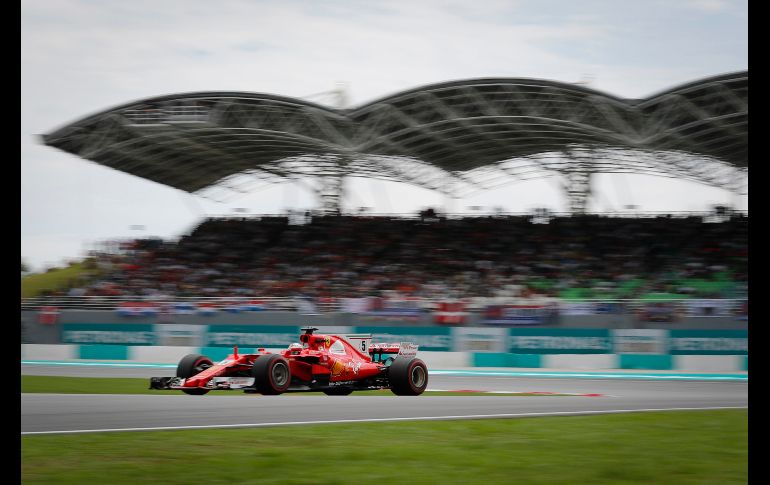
[{"x1": 52, "y1": 323, "x2": 748, "y2": 360}]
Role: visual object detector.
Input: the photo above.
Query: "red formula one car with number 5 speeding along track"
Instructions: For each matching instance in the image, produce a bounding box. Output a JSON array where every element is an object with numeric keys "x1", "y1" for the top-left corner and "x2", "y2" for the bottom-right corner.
[{"x1": 150, "y1": 327, "x2": 428, "y2": 396}]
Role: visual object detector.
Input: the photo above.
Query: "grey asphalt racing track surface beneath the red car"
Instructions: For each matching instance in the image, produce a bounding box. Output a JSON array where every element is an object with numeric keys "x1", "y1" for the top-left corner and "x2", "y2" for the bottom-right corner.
[{"x1": 21, "y1": 369, "x2": 748, "y2": 434}]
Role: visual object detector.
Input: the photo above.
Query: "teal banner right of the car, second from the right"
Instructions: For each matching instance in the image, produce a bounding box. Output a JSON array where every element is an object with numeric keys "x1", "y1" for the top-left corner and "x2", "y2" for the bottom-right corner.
[{"x1": 508, "y1": 328, "x2": 612, "y2": 354}]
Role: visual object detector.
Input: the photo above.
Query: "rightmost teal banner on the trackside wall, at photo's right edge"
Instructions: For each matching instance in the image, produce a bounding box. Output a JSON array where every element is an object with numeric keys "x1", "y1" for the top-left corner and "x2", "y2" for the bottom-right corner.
[{"x1": 669, "y1": 330, "x2": 749, "y2": 355}]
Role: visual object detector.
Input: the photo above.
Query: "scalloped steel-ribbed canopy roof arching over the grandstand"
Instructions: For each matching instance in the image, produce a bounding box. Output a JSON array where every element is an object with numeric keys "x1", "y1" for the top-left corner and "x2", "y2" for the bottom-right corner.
[{"x1": 43, "y1": 71, "x2": 748, "y2": 211}]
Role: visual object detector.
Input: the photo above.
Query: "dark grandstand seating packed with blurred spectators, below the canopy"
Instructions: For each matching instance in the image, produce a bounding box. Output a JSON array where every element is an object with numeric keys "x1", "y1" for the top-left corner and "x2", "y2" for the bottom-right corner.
[{"x1": 60, "y1": 215, "x2": 748, "y2": 300}]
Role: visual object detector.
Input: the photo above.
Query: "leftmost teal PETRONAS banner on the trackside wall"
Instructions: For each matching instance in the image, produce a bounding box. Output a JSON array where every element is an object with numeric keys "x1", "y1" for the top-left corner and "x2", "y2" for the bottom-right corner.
[{"x1": 61, "y1": 323, "x2": 159, "y2": 345}]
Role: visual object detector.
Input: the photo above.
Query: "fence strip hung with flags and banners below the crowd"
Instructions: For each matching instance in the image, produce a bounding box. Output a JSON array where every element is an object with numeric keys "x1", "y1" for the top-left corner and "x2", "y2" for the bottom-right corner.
[{"x1": 21, "y1": 295, "x2": 748, "y2": 325}]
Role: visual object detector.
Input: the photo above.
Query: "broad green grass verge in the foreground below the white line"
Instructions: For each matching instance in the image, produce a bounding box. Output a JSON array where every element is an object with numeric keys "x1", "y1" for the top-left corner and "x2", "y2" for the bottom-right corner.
[{"x1": 21, "y1": 410, "x2": 748, "y2": 485}]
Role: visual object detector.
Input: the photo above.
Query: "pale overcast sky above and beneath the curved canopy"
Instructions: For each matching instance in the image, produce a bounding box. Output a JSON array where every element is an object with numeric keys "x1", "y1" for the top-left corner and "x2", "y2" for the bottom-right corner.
[{"x1": 21, "y1": 0, "x2": 748, "y2": 270}]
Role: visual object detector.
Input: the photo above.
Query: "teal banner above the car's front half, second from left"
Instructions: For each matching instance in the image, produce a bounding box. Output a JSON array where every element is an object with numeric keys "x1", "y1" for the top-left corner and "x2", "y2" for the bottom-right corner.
[{"x1": 204, "y1": 325, "x2": 300, "y2": 348}]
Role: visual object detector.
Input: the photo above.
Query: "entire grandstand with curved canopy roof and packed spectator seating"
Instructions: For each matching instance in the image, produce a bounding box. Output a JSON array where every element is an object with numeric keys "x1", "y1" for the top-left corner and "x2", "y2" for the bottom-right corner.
[{"x1": 29, "y1": 72, "x2": 748, "y2": 328}]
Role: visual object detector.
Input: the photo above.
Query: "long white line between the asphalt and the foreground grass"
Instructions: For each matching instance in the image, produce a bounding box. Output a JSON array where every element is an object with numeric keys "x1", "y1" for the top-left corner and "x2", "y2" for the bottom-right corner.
[{"x1": 21, "y1": 406, "x2": 748, "y2": 435}]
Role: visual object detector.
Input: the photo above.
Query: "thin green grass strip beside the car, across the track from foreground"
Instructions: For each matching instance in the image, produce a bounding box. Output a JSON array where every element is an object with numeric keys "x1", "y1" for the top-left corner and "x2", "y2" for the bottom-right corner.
[{"x1": 21, "y1": 372, "x2": 556, "y2": 396}]
